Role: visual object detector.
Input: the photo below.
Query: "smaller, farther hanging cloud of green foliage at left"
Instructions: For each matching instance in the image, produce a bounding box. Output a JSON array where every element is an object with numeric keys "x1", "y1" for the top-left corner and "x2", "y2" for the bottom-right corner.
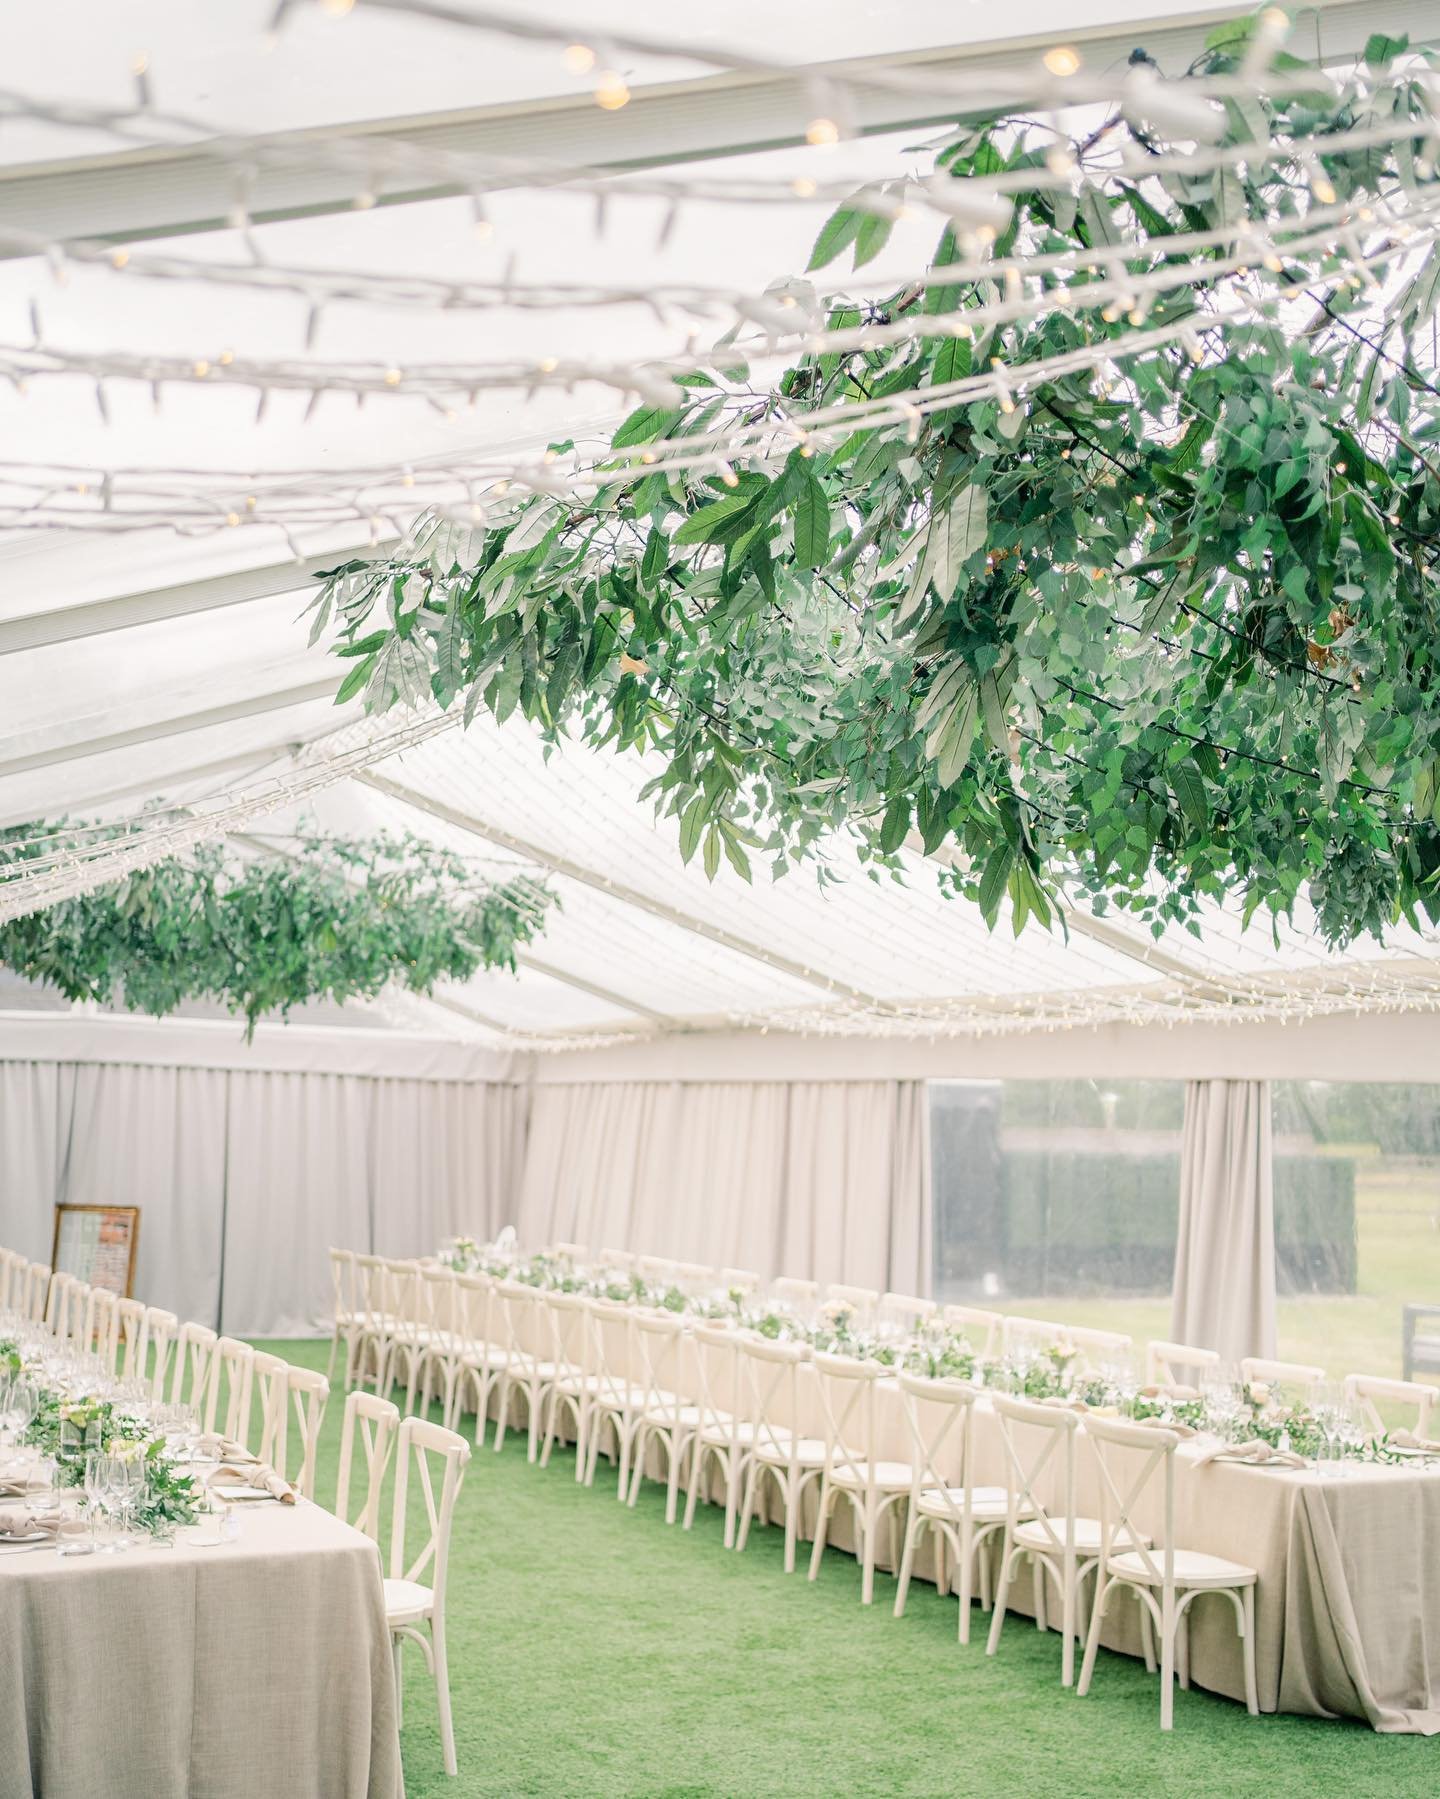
[{"x1": 0, "y1": 826, "x2": 553, "y2": 1031}]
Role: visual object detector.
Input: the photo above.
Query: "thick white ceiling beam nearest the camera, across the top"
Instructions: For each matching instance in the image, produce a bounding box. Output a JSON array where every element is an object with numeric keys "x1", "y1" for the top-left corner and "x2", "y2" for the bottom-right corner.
[{"x1": 0, "y1": 0, "x2": 1411, "y2": 257}]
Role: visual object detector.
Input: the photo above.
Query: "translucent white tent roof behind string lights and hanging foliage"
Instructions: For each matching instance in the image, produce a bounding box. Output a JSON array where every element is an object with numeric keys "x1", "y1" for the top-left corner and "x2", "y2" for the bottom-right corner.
[{"x1": 0, "y1": 0, "x2": 1440, "y2": 1047}]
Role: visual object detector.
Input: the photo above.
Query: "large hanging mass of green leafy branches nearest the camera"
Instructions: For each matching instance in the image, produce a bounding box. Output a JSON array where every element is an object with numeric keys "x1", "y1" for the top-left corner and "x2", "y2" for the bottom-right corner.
[{"x1": 317, "y1": 23, "x2": 1440, "y2": 943}]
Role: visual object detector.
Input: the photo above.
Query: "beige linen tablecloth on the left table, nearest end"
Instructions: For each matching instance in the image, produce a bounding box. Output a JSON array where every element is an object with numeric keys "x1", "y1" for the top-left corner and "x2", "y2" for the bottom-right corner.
[{"x1": 0, "y1": 1502, "x2": 400, "y2": 1799}]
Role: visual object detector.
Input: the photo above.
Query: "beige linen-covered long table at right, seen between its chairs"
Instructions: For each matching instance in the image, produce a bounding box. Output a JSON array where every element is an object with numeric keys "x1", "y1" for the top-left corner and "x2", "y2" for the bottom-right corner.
[{"x1": 493, "y1": 1320, "x2": 1440, "y2": 1736}]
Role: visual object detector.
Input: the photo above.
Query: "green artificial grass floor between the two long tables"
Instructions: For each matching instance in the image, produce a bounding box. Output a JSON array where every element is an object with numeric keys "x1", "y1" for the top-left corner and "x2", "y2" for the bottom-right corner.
[{"x1": 253, "y1": 1342, "x2": 1440, "y2": 1799}]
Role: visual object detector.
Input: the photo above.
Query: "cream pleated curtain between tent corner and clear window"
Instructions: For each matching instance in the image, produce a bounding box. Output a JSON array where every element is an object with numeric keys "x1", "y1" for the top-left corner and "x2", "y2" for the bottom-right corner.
[{"x1": 515, "y1": 1081, "x2": 931, "y2": 1293}]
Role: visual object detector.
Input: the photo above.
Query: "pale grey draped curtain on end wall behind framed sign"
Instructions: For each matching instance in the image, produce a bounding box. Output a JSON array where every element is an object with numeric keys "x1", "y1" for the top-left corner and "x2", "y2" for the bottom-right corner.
[{"x1": 0, "y1": 1061, "x2": 526, "y2": 1335}]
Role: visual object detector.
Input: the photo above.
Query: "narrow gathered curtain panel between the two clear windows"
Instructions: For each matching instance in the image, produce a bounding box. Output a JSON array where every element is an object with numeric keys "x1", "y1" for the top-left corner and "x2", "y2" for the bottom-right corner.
[{"x1": 1170, "y1": 1081, "x2": 1274, "y2": 1362}]
